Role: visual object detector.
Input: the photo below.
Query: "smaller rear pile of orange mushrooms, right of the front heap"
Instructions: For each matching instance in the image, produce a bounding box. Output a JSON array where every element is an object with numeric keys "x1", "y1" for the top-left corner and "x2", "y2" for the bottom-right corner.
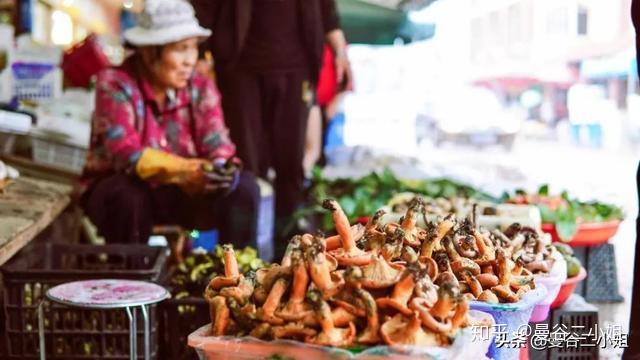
[{"x1": 384, "y1": 198, "x2": 554, "y2": 303}]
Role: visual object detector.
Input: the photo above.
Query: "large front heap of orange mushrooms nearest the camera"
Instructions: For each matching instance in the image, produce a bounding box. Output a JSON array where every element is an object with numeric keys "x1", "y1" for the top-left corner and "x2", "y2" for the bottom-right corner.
[{"x1": 205, "y1": 200, "x2": 500, "y2": 347}]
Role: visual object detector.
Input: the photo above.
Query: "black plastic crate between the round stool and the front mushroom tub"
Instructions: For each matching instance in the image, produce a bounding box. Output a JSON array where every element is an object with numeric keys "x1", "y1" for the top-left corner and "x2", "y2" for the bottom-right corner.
[{"x1": 159, "y1": 297, "x2": 211, "y2": 360}]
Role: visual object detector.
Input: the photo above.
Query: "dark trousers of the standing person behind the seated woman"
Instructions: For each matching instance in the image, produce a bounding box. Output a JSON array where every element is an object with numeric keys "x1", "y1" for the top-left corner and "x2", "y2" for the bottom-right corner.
[{"x1": 216, "y1": 64, "x2": 311, "y2": 258}]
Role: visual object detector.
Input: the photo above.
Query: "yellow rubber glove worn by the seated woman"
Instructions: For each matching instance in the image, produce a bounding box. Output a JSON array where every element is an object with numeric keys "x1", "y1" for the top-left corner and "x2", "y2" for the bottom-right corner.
[{"x1": 136, "y1": 148, "x2": 208, "y2": 192}]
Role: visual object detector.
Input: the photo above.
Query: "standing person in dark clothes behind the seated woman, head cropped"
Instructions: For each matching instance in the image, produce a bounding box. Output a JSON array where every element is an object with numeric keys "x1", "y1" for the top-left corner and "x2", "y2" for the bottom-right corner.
[{"x1": 193, "y1": 0, "x2": 350, "y2": 255}]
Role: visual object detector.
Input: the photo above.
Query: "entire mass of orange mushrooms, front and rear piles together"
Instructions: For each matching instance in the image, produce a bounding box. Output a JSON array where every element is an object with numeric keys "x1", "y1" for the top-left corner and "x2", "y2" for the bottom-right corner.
[{"x1": 205, "y1": 199, "x2": 549, "y2": 347}]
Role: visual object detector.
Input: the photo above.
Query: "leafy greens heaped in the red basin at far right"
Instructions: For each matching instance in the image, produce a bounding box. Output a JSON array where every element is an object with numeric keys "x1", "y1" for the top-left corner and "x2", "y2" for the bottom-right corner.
[{"x1": 503, "y1": 184, "x2": 624, "y2": 241}]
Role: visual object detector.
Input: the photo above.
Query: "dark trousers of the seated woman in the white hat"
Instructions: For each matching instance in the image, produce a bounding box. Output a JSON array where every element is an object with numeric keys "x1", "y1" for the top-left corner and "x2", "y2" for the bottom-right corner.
[{"x1": 82, "y1": 172, "x2": 260, "y2": 247}]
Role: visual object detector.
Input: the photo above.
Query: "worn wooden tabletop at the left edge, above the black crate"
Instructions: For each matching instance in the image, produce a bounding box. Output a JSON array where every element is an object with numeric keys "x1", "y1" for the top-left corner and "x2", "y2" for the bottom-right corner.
[{"x1": 0, "y1": 177, "x2": 72, "y2": 265}]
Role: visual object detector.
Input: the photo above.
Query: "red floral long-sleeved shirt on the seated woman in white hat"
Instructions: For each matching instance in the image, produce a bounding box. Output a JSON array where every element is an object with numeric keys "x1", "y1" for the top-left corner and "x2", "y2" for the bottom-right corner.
[{"x1": 85, "y1": 57, "x2": 235, "y2": 177}]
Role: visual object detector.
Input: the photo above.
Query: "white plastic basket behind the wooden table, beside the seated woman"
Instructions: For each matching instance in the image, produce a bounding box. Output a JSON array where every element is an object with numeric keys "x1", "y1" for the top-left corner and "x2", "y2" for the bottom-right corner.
[{"x1": 32, "y1": 137, "x2": 87, "y2": 174}]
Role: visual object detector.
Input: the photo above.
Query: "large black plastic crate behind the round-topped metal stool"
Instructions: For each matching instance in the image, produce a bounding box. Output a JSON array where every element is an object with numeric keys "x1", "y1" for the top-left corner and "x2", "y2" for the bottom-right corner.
[{"x1": 1, "y1": 243, "x2": 166, "y2": 360}]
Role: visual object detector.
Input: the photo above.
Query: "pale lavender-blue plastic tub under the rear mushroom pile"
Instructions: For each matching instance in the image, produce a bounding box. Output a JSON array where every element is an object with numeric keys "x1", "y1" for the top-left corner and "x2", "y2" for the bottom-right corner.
[{"x1": 471, "y1": 286, "x2": 547, "y2": 360}]
